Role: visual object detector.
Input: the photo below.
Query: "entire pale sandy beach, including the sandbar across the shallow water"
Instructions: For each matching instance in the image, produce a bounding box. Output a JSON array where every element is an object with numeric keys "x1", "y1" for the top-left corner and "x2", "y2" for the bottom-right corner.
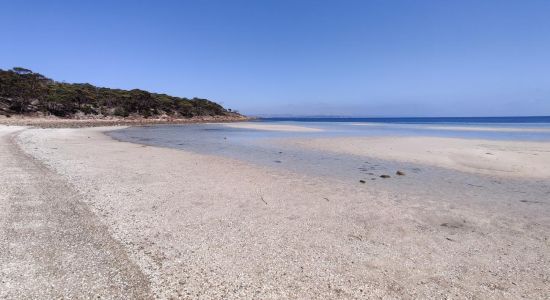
[{"x1": 0, "y1": 124, "x2": 550, "y2": 299}]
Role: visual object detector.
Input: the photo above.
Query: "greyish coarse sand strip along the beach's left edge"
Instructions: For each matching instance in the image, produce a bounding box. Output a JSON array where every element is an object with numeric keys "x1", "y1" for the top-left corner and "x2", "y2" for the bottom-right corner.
[{"x1": 0, "y1": 130, "x2": 150, "y2": 299}]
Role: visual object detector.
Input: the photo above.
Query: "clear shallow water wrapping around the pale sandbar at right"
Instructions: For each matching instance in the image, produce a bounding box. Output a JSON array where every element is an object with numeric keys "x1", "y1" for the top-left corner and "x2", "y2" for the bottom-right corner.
[{"x1": 109, "y1": 121, "x2": 550, "y2": 211}]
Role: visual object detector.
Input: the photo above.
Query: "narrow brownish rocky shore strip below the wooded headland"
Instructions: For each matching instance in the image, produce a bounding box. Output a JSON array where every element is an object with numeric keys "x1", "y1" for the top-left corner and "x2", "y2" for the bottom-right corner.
[{"x1": 0, "y1": 116, "x2": 253, "y2": 128}]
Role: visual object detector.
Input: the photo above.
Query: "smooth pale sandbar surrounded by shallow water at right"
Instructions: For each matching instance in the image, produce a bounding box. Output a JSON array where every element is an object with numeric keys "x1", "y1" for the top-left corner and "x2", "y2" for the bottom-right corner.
[{"x1": 286, "y1": 137, "x2": 550, "y2": 178}]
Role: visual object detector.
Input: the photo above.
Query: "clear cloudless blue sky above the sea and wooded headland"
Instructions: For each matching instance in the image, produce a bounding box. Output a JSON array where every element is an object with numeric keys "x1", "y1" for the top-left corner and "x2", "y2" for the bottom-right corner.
[{"x1": 0, "y1": 0, "x2": 550, "y2": 116}]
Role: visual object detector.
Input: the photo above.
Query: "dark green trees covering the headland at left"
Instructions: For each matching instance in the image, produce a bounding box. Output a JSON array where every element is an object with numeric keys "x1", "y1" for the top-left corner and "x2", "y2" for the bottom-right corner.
[{"x1": 0, "y1": 68, "x2": 235, "y2": 118}]
